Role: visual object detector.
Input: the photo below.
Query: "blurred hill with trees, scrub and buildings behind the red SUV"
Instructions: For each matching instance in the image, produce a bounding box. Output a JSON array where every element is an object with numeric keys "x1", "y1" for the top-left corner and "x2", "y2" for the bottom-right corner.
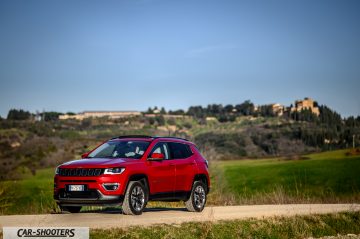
[{"x1": 0, "y1": 101, "x2": 360, "y2": 180}]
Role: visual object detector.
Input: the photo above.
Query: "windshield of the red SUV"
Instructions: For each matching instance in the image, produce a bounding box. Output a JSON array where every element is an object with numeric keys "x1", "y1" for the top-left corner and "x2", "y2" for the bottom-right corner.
[{"x1": 88, "y1": 140, "x2": 150, "y2": 159}]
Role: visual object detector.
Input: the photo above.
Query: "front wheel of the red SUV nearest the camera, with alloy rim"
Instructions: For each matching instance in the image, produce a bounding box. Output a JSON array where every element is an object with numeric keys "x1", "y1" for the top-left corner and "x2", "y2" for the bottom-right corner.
[{"x1": 122, "y1": 181, "x2": 148, "y2": 215}]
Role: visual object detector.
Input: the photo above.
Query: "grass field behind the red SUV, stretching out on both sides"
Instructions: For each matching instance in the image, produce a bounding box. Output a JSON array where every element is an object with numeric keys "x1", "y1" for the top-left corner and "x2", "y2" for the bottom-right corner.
[{"x1": 0, "y1": 150, "x2": 360, "y2": 214}]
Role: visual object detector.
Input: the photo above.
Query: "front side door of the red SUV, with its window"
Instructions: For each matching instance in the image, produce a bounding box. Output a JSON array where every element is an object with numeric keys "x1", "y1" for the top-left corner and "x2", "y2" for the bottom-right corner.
[{"x1": 147, "y1": 142, "x2": 175, "y2": 195}]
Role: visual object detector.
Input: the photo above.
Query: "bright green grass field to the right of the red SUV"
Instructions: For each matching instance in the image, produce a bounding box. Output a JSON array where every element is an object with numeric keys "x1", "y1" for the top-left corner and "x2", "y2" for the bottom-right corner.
[{"x1": 220, "y1": 150, "x2": 360, "y2": 203}]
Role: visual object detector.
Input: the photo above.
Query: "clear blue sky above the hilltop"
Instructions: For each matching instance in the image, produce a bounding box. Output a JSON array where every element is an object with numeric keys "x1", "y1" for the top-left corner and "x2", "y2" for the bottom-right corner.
[{"x1": 0, "y1": 0, "x2": 360, "y2": 117}]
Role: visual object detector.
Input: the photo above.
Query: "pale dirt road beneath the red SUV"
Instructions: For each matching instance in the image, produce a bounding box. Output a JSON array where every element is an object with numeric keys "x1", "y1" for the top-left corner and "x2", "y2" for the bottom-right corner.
[{"x1": 0, "y1": 204, "x2": 360, "y2": 230}]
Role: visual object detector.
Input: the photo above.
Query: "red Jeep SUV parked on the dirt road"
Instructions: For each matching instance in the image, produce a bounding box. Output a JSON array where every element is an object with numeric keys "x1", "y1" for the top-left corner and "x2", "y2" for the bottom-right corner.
[{"x1": 54, "y1": 135, "x2": 210, "y2": 215}]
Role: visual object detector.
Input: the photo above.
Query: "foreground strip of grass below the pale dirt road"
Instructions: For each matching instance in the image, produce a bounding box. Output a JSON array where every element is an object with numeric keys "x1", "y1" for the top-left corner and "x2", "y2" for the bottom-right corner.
[{"x1": 90, "y1": 212, "x2": 360, "y2": 239}]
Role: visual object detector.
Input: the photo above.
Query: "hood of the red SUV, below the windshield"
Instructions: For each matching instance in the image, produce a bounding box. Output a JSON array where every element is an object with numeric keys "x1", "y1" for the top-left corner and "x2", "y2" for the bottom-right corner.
[{"x1": 60, "y1": 158, "x2": 132, "y2": 168}]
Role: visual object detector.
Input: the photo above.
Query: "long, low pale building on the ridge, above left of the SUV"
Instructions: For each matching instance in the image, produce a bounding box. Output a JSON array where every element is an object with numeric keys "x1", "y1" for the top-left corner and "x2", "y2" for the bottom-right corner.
[{"x1": 59, "y1": 111, "x2": 141, "y2": 120}]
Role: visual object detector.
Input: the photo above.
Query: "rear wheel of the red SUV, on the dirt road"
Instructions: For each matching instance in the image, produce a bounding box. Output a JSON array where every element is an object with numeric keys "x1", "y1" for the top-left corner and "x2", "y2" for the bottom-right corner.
[{"x1": 185, "y1": 181, "x2": 207, "y2": 212}]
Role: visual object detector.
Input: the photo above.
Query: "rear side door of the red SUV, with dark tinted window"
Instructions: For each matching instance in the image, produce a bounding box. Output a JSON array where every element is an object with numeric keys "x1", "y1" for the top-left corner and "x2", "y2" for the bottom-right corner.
[{"x1": 168, "y1": 142, "x2": 197, "y2": 192}]
